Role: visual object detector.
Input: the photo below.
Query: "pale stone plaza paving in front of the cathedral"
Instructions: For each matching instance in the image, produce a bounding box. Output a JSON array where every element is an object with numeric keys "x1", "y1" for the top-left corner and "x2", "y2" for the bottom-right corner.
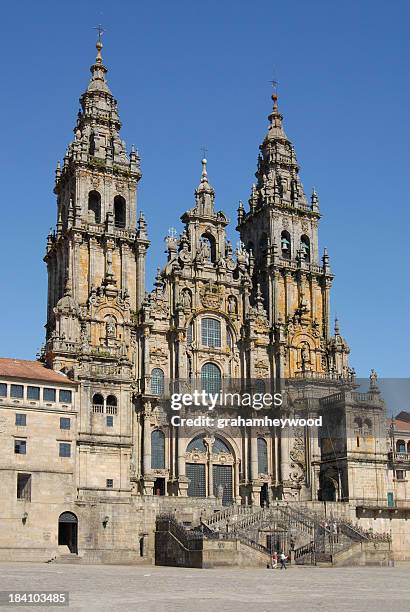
[{"x1": 0, "y1": 563, "x2": 410, "y2": 612}]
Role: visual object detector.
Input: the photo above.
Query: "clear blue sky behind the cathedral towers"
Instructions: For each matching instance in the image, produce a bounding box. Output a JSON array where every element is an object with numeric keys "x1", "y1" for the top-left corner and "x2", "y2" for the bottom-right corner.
[{"x1": 0, "y1": 0, "x2": 410, "y2": 377}]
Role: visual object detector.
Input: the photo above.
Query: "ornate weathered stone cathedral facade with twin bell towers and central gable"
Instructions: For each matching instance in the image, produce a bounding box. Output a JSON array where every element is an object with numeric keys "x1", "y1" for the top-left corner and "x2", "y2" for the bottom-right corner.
[{"x1": 0, "y1": 42, "x2": 406, "y2": 555}]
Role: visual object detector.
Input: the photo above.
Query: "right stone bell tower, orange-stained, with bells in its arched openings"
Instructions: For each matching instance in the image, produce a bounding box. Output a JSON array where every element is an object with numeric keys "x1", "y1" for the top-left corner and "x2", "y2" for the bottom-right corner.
[{"x1": 238, "y1": 93, "x2": 349, "y2": 378}]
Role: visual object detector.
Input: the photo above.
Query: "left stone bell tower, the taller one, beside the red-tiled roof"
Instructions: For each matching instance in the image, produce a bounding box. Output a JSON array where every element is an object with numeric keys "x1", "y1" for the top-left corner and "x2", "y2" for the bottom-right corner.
[{"x1": 45, "y1": 40, "x2": 149, "y2": 369}]
